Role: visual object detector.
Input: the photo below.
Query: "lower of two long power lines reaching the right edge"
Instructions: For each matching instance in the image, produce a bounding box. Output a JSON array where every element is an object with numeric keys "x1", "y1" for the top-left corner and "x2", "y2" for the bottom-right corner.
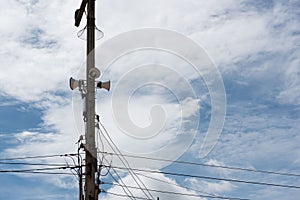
[{"x1": 106, "y1": 166, "x2": 300, "y2": 189}]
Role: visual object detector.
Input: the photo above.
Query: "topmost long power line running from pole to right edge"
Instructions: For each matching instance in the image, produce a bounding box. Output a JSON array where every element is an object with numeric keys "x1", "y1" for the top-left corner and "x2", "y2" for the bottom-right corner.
[{"x1": 100, "y1": 152, "x2": 300, "y2": 177}]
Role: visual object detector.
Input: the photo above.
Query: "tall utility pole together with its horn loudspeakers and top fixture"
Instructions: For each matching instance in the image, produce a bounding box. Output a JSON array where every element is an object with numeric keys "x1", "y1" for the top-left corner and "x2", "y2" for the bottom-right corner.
[{"x1": 74, "y1": 0, "x2": 110, "y2": 200}]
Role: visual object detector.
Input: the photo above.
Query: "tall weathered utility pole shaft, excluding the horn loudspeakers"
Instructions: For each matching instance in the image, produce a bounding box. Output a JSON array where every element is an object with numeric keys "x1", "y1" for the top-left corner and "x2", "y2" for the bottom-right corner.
[{"x1": 75, "y1": 0, "x2": 99, "y2": 200}]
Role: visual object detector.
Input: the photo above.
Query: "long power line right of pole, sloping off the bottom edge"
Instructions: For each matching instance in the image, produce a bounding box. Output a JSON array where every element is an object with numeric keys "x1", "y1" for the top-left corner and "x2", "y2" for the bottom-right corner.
[{"x1": 102, "y1": 182, "x2": 249, "y2": 200}]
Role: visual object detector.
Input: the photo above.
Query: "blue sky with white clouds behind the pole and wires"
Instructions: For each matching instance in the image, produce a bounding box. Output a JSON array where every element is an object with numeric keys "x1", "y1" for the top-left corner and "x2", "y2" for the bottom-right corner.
[{"x1": 0, "y1": 0, "x2": 300, "y2": 200}]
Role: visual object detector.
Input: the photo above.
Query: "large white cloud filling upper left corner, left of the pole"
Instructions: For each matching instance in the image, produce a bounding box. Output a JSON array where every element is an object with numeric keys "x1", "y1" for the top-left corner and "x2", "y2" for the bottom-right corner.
[{"x1": 0, "y1": 1, "x2": 83, "y2": 101}]
